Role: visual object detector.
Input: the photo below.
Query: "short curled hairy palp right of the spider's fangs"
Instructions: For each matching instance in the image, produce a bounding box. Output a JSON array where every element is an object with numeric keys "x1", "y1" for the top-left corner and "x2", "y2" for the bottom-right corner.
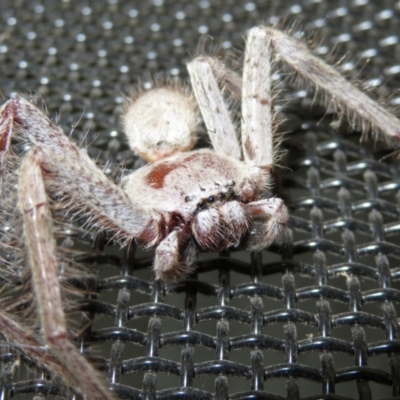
[{"x1": 246, "y1": 197, "x2": 289, "y2": 250}]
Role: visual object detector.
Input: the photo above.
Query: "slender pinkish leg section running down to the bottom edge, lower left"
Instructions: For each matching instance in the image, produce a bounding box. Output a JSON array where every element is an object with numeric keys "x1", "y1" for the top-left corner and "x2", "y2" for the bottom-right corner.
[{"x1": 18, "y1": 151, "x2": 113, "y2": 400}]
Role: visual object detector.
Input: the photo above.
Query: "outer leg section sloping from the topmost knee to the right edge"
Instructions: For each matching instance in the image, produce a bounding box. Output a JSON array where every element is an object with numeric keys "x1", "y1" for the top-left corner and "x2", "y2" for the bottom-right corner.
[{"x1": 258, "y1": 27, "x2": 400, "y2": 144}]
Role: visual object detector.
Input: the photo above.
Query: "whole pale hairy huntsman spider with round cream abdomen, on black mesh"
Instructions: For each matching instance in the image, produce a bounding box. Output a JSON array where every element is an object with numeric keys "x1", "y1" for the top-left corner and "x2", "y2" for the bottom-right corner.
[{"x1": 0, "y1": 27, "x2": 400, "y2": 399}]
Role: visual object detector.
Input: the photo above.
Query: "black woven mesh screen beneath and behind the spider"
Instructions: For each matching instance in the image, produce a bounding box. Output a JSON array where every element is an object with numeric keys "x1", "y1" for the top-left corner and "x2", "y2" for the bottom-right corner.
[{"x1": 0, "y1": 0, "x2": 400, "y2": 399}]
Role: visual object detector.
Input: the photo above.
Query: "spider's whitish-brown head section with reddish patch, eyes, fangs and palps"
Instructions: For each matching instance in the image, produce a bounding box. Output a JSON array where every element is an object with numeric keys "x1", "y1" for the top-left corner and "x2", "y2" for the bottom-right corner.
[{"x1": 122, "y1": 145, "x2": 288, "y2": 278}]
